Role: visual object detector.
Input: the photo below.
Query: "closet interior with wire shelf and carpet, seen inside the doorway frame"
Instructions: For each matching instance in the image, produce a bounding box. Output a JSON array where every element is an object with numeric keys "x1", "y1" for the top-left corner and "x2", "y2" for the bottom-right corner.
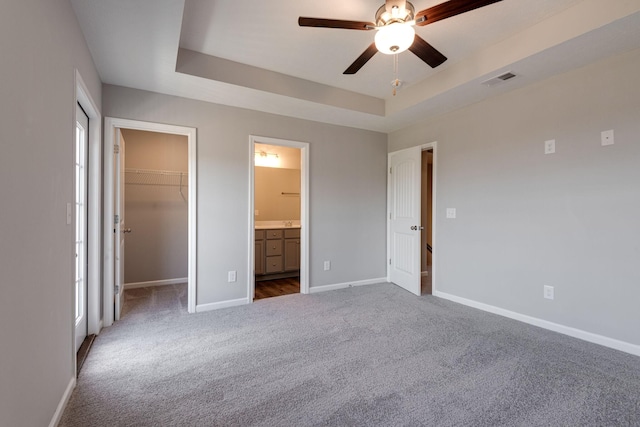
[{"x1": 120, "y1": 129, "x2": 189, "y2": 316}]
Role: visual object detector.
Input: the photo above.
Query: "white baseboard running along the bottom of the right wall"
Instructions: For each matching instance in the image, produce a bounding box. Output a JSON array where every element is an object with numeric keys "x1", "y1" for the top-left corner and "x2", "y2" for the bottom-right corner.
[{"x1": 433, "y1": 291, "x2": 640, "y2": 356}]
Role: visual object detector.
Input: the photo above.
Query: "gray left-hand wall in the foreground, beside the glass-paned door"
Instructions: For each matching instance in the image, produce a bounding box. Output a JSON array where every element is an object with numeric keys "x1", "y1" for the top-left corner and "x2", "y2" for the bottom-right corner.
[{"x1": 0, "y1": 0, "x2": 101, "y2": 426}]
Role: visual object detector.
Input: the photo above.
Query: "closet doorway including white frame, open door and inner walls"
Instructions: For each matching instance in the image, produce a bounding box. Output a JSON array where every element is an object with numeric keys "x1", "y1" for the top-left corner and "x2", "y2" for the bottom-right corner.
[{"x1": 104, "y1": 118, "x2": 197, "y2": 326}]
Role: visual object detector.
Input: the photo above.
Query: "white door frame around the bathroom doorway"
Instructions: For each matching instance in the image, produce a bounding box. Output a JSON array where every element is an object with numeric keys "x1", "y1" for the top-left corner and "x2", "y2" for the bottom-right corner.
[{"x1": 247, "y1": 135, "x2": 309, "y2": 303}]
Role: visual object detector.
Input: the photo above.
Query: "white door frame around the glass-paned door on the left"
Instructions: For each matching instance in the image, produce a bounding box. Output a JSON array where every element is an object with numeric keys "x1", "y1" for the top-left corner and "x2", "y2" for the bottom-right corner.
[{"x1": 72, "y1": 69, "x2": 102, "y2": 342}]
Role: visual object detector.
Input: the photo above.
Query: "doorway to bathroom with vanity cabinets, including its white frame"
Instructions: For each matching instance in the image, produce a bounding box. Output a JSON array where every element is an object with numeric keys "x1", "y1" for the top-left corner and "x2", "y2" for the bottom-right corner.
[{"x1": 248, "y1": 137, "x2": 309, "y2": 301}]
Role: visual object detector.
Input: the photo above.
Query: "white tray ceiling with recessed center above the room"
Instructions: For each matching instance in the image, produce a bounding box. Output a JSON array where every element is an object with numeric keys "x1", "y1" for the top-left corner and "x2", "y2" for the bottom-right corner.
[{"x1": 71, "y1": 0, "x2": 640, "y2": 132}]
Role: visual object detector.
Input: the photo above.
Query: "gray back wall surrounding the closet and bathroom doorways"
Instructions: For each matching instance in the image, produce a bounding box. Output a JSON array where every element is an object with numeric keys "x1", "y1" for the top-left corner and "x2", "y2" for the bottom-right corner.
[{"x1": 103, "y1": 85, "x2": 387, "y2": 304}]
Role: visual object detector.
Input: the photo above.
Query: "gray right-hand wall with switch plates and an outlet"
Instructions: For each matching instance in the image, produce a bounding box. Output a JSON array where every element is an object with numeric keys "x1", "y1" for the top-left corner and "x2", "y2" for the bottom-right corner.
[{"x1": 389, "y1": 51, "x2": 640, "y2": 345}]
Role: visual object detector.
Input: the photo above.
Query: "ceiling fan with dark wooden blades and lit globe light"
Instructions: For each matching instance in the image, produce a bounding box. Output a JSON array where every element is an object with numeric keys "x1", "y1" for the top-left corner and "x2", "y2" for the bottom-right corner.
[{"x1": 298, "y1": 0, "x2": 502, "y2": 74}]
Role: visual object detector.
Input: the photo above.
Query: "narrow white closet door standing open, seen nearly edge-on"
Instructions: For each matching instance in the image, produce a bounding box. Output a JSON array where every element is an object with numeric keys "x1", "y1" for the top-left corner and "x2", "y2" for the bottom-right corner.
[{"x1": 113, "y1": 130, "x2": 126, "y2": 320}]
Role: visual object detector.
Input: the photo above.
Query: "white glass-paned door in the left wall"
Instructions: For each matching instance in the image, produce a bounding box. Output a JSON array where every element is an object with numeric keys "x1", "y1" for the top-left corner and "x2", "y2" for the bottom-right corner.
[{"x1": 74, "y1": 105, "x2": 89, "y2": 352}]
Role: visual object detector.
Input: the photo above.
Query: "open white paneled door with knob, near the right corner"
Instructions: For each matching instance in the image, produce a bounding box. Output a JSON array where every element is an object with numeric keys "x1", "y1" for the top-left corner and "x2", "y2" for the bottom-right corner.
[{"x1": 389, "y1": 147, "x2": 422, "y2": 295}]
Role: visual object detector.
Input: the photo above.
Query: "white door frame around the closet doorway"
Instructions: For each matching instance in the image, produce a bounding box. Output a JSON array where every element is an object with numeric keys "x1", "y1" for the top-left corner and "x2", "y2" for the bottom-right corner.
[{"x1": 103, "y1": 117, "x2": 198, "y2": 326}]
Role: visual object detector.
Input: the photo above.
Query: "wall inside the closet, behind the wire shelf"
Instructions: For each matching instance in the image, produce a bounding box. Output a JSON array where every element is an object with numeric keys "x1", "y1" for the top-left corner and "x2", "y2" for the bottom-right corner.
[{"x1": 122, "y1": 129, "x2": 189, "y2": 283}]
